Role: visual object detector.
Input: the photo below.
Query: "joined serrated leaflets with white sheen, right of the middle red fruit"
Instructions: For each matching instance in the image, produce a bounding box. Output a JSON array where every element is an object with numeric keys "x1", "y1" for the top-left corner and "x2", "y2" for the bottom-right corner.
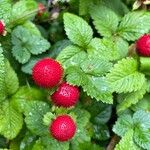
[{"x1": 66, "y1": 66, "x2": 113, "y2": 103}]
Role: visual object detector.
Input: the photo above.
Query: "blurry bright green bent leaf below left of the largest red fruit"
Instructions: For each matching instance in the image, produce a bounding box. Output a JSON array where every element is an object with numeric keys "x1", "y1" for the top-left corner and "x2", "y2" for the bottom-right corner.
[{"x1": 11, "y1": 86, "x2": 46, "y2": 112}]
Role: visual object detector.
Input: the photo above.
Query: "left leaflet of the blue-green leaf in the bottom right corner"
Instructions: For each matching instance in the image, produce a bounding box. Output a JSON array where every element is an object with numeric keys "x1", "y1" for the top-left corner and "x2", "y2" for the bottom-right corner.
[{"x1": 113, "y1": 114, "x2": 133, "y2": 137}]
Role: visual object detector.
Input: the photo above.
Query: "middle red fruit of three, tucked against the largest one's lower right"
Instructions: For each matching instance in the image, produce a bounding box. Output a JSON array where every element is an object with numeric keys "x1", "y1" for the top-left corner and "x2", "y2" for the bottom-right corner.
[{"x1": 51, "y1": 82, "x2": 80, "y2": 107}]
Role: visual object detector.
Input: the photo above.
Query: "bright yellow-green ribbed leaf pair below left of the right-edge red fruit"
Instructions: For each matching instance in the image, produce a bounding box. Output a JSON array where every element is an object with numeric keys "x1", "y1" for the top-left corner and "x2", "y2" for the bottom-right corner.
[{"x1": 107, "y1": 57, "x2": 146, "y2": 93}]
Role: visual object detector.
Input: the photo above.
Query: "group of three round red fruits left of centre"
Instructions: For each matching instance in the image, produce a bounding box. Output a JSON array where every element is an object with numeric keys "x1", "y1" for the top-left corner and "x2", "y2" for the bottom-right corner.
[{"x1": 32, "y1": 58, "x2": 80, "y2": 142}]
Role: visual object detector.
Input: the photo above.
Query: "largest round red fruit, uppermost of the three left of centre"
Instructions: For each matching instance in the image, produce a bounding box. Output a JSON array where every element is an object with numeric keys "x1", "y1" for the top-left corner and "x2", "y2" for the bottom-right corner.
[{"x1": 32, "y1": 58, "x2": 63, "y2": 88}]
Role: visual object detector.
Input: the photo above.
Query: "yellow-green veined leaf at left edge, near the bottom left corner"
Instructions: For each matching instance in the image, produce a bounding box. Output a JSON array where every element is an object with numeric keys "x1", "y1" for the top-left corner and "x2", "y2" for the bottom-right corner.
[{"x1": 0, "y1": 100, "x2": 23, "y2": 140}]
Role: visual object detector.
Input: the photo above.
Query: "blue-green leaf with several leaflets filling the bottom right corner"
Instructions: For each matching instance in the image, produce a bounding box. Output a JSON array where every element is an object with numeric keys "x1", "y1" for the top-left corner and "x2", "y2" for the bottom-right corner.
[{"x1": 113, "y1": 110, "x2": 150, "y2": 149}]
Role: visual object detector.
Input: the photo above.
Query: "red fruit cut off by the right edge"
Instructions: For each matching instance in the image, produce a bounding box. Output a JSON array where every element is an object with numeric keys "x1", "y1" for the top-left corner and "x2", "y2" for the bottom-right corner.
[{"x1": 136, "y1": 34, "x2": 150, "y2": 57}]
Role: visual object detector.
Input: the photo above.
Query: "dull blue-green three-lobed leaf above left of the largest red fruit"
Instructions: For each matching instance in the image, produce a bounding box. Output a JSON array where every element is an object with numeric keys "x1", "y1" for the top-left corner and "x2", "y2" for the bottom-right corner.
[{"x1": 12, "y1": 26, "x2": 50, "y2": 64}]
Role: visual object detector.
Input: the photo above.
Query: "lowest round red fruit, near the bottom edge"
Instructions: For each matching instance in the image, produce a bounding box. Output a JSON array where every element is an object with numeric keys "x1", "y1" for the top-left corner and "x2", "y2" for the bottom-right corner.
[{"x1": 49, "y1": 115, "x2": 76, "y2": 142}]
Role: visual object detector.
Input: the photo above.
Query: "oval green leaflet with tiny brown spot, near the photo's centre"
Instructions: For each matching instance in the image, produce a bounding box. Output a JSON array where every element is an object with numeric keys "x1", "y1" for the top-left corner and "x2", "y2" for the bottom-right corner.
[{"x1": 81, "y1": 57, "x2": 112, "y2": 76}]
